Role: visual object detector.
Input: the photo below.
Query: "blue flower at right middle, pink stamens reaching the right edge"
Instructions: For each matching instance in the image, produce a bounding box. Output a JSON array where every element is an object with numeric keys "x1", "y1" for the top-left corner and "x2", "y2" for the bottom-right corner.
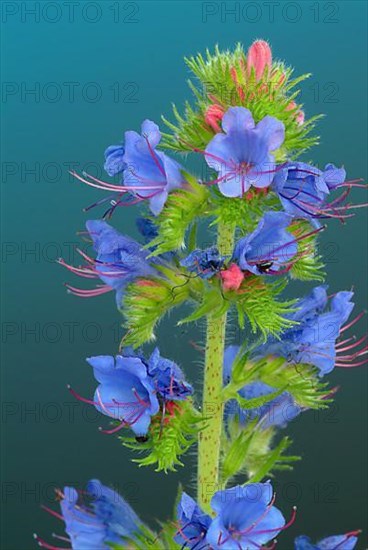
[{"x1": 253, "y1": 286, "x2": 356, "y2": 376}]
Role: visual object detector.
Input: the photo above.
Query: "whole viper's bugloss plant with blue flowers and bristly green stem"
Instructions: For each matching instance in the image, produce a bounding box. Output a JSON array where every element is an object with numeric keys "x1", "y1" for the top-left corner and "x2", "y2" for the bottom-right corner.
[{"x1": 36, "y1": 40, "x2": 368, "y2": 550}]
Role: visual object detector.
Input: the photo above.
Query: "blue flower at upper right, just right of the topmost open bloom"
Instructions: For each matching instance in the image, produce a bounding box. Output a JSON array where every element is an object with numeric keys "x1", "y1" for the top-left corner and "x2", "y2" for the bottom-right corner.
[{"x1": 272, "y1": 162, "x2": 346, "y2": 226}]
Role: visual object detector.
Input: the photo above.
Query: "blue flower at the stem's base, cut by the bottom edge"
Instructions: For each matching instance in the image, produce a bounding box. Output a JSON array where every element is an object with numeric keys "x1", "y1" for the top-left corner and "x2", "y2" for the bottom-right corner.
[{"x1": 206, "y1": 483, "x2": 287, "y2": 550}]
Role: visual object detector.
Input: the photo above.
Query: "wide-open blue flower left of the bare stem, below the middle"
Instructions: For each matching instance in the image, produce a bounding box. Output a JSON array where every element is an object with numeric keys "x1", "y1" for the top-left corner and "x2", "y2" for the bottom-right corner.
[{"x1": 87, "y1": 355, "x2": 160, "y2": 437}]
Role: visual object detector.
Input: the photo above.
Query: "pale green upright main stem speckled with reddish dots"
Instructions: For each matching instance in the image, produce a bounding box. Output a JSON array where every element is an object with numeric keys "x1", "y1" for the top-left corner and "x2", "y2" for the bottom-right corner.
[{"x1": 197, "y1": 225, "x2": 234, "y2": 511}]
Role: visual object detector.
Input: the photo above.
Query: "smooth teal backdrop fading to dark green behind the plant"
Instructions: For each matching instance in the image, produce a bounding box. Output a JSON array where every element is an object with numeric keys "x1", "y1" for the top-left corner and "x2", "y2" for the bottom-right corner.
[{"x1": 1, "y1": 0, "x2": 367, "y2": 550}]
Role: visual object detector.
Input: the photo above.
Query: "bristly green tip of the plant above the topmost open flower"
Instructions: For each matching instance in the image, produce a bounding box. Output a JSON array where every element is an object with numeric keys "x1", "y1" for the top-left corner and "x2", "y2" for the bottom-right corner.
[{"x1": 162, "y1": 44, "x2": 322, "y2": 158}]
